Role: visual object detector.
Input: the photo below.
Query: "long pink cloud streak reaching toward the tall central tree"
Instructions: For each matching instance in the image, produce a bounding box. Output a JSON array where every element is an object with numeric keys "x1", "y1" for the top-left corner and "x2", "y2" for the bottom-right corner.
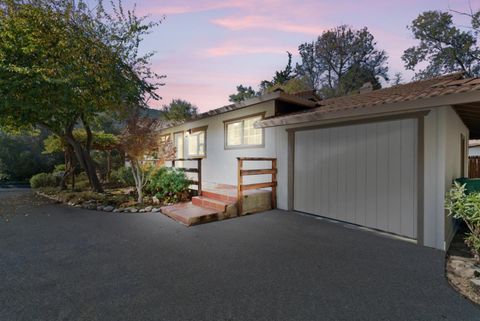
[{"x1": 212, "y1": 16, "x2": 324, "y2": 35}]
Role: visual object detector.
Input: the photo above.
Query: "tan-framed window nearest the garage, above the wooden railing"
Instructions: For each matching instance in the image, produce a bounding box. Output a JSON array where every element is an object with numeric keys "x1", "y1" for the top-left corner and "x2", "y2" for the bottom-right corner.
[{"x1": 225, "y1": 115, "x2": 263, "y2": 148}]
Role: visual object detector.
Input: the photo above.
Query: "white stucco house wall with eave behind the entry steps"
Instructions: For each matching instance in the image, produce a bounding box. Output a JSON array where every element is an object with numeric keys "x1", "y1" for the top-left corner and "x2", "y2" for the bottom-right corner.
[{"x1": 162, "y1": 101, "x2": 277, "y2": 185}]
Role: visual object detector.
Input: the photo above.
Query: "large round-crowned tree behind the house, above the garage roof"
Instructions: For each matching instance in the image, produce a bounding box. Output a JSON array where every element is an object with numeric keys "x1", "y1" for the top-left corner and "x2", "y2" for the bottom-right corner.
[{"x1": 296, "y1": 25, "x2": 388, "y2": 97}]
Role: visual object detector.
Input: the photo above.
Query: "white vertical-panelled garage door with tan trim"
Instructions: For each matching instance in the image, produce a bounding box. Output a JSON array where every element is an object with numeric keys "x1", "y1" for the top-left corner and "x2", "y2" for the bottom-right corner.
[{"x1": 294, "y1": 119, "x2": 417, "y2": 238}]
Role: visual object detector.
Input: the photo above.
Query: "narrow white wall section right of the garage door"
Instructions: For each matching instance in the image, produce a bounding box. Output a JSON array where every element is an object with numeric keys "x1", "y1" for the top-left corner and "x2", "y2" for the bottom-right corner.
[{"x1": 424, "y1": 106, "x2": 468, "y2": 249}]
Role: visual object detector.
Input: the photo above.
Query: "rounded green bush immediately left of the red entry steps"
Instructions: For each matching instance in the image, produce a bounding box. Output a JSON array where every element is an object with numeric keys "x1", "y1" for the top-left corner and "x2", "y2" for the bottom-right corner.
[{"x1": 146, "y1": 167, "x2": 191, "y2": 203}]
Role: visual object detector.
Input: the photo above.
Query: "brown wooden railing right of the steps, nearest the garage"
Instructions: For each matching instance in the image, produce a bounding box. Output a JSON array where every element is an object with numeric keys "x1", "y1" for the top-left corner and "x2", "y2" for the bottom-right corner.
[{"x1": 237, "y1": 157, "x2": 277, "y2": 215}]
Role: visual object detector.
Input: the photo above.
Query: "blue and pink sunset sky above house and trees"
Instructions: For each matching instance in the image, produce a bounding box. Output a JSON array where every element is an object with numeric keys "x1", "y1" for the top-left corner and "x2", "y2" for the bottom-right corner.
[{"x1": 119, "y1": 0, "x2": 480, "y2": 111}]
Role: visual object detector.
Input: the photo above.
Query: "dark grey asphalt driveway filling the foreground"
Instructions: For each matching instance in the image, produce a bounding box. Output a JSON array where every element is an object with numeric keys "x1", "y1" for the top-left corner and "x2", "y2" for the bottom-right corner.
[{"x1": 0, "y1": 190, "x2": 480, "y2": 321}]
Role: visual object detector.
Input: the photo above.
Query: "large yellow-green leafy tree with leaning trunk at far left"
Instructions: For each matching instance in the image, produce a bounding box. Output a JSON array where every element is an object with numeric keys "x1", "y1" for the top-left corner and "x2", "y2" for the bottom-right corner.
[{"x1": 0, "y1": 0, "x2": 162, "y2": 192}]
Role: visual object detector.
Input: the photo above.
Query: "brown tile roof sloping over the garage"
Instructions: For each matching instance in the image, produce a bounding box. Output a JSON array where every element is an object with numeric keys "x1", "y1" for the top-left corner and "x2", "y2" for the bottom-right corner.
[{"x1": 259, "y1": 73, "x2": 480, "y2": 127}]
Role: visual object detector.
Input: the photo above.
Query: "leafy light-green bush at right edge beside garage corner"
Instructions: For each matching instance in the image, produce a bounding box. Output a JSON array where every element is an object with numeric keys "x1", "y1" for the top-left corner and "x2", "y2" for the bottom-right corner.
[{"x1": 445, "y1": 182, "x2": 480, "y2": 261}]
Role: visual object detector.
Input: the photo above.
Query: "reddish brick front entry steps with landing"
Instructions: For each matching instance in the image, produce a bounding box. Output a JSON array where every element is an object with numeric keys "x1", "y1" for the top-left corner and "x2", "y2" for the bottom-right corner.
[{"x1": 161, "y1": 182, "x2": 271, "y2": 226}]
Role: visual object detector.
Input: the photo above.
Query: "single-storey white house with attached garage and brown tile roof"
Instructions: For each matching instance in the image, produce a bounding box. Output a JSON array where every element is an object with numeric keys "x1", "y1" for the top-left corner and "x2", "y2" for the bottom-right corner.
[{"x1": 161, "y1": 73, "x2": 480, "y2": 250}]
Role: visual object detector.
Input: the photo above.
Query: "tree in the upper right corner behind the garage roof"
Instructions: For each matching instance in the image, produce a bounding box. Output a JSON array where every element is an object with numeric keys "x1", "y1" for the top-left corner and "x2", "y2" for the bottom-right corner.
[{"x1": 402, "y1": 11, "x2": 480, "y2": 79}]
